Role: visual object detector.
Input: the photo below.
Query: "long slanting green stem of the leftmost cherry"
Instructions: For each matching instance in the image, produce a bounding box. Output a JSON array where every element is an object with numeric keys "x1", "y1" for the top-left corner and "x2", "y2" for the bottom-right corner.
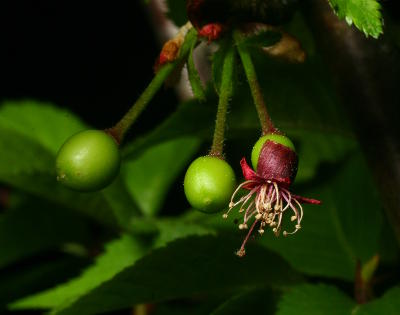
[{"x1": 107, "y1": 29, "x2": 197, "y2": 143}]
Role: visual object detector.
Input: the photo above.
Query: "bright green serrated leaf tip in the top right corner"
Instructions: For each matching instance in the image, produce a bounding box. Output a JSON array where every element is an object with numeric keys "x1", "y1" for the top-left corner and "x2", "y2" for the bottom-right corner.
[{"x1": 329, "y1": 0, "x2": 383, "y2": 38}]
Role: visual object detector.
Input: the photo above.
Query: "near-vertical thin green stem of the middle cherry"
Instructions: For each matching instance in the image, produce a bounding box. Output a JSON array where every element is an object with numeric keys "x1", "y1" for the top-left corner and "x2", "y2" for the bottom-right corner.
[{"x1": 210, "y1": 43, "x2": 235, "y2": 158}]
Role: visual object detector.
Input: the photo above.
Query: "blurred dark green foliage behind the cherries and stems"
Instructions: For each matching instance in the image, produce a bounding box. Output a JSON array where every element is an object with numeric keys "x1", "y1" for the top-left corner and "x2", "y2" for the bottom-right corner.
[{"x1": 0, "y1": 1, "x2": 400, "y2": 315}]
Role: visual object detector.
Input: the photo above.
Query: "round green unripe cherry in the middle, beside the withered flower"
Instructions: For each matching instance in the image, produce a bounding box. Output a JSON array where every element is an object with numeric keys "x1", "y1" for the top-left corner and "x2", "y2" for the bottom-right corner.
[{"x1": 183, "y1": 156, "x2": 236, "y2": 213}]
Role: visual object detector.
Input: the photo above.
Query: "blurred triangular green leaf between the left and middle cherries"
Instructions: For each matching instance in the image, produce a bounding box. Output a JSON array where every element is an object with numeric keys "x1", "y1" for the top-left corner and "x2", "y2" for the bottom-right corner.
[{"x1": 121, "y1": 137, "x2": 200, "y2": 216}]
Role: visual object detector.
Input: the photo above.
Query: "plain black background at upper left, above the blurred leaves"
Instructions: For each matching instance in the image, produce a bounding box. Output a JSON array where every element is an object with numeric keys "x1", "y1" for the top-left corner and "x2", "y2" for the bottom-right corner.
[{"x1": 0, "y1": 0, "x2": 177, "y2": 137}]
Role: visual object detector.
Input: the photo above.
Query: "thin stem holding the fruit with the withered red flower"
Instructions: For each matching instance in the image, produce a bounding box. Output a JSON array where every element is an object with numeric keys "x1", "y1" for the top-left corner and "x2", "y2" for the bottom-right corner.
[{"x1": 234, "y1": 32, "x2": 277, "y2": 135}]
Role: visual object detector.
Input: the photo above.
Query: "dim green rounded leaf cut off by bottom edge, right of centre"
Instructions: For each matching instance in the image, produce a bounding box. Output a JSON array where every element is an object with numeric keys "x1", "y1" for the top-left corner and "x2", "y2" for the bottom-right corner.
[{"x1": 276, "y1": 284, "x2": 354, "y2": 315}]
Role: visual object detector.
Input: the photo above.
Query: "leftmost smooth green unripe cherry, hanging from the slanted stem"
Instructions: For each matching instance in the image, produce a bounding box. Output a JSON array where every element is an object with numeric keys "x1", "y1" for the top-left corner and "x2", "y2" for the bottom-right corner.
[{"x1": 56, "y1": 130, "x2": 121, "y2": 191}]
